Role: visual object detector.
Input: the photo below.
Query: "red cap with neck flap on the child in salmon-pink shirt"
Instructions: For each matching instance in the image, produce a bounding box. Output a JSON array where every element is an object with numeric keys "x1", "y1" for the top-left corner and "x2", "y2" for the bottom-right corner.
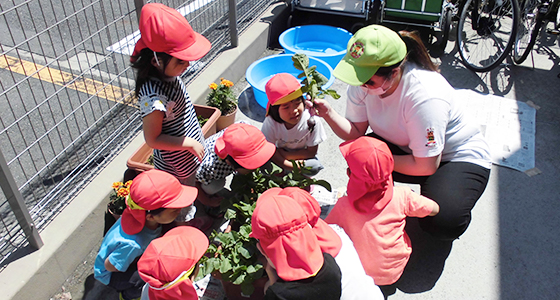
[{"x1": 339, "y1": 136, "x2": 394, "y2": 213}]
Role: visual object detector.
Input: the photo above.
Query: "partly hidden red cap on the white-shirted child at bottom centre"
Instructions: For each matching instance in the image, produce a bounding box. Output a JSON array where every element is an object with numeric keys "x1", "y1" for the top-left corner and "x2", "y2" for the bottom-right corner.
[{"x1": 280, "y1": 187, "x2": 342, "y2": 257}]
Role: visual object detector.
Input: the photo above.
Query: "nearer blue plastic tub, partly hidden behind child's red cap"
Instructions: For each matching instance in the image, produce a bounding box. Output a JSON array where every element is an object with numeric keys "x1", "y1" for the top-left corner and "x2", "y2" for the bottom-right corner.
[{"x1": 245, "y1": 54, "x2": 334, "y2": 109}]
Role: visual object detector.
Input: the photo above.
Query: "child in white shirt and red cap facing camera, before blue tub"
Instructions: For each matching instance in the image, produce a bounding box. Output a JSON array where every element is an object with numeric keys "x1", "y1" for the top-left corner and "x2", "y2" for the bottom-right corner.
[{"x1": 261, "y1": 73, "x2": 327, "y2": 176}]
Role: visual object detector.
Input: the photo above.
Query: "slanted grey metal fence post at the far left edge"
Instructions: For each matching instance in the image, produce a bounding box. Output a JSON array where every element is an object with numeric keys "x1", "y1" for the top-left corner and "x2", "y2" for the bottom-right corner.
[{"x1": 0, "y1": 151, "x2": 43, "y2": 249}]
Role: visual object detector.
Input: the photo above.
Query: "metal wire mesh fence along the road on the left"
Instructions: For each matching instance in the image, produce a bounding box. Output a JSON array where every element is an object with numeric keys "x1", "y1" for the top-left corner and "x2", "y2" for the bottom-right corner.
[{"x1": 0, "y1": 0, "x2": 274, "y2": 270}]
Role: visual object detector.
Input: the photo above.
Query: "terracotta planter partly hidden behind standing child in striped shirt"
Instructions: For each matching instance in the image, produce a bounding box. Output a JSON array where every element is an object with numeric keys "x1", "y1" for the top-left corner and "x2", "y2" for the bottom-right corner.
[{"x1": 126, "y1": 104, "x2": 220, "y2": 173}]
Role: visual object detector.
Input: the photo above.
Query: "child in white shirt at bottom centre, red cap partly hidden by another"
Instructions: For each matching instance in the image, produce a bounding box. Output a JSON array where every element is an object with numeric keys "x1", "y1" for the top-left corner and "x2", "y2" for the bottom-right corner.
[{"x1": 277, "y1": 187, "x2": 385, "y2": 300}]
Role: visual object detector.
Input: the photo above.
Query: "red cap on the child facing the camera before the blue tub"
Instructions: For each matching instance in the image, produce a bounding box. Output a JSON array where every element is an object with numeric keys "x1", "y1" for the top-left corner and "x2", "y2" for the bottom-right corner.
[{"x1": 264, "y1": 73, "x2": 302, "y2": 116}]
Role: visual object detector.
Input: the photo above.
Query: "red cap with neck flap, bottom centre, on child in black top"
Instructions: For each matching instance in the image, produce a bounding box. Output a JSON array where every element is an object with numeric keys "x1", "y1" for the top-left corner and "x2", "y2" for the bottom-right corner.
[{"x1": 250, "y1": 188, "x2": 323, "y2": 281}]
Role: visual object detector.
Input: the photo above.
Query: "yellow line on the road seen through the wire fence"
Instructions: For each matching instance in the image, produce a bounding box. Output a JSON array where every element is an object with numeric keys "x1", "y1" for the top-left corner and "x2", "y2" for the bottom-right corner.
[{"x1": 0, "y1": 55, "x2": 133, "y2": 105}]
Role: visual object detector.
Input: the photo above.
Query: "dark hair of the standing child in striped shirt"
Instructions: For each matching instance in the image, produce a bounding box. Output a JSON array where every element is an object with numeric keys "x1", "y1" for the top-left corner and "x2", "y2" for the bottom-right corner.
[{"x1": 132, "y1": 48, "x2": 172, "y2": 95}]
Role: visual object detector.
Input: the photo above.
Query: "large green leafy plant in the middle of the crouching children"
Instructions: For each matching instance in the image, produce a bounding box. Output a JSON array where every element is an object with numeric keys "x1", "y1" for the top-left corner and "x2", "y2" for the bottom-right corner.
[{"x1": 197, "y1": 161, "x2": 331, "y2": 295}]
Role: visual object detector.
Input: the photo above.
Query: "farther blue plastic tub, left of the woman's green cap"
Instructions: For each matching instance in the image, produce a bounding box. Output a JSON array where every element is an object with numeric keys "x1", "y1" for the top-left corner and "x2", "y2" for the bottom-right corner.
[{"x1": 278, "y1": 25, "x2": 352, "y2": 69}]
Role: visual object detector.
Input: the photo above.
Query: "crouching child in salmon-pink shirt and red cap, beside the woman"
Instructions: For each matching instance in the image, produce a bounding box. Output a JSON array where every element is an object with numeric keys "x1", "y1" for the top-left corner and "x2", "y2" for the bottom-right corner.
[{"x1": 325, "y1": 136, "x2": 439, "y2": 285}]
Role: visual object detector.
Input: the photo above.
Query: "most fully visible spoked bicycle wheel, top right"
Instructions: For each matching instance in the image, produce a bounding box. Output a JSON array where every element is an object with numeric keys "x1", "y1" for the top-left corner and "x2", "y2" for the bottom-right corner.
[{"x1": 457, "y1": 0, "x2": 519, "y2": 72}]
